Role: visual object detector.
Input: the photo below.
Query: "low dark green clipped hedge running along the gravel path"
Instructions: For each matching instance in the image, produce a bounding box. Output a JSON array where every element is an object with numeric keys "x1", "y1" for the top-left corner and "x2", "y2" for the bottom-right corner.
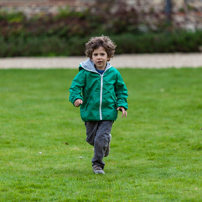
[{"x1": 0, "y1": 31, "x2": 202, "y2": 57}]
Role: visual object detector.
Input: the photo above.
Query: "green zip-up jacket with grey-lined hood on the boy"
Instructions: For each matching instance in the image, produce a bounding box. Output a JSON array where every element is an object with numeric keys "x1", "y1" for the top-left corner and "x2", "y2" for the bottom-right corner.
[{"x1": 69, "y1": 59, "x2": 128, "y2": 121}]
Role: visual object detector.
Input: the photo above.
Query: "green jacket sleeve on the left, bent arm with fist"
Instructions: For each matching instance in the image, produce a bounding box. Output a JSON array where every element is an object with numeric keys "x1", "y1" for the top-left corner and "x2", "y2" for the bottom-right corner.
[{"x1": 69, "y1": 70, "x2": 85, "y2": 104}]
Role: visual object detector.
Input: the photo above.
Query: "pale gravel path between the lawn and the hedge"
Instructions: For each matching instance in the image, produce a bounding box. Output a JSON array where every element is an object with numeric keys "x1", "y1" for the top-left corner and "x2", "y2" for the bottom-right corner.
[{"x1": 0, "y1": 53, "x2": 202, "y2": 69}]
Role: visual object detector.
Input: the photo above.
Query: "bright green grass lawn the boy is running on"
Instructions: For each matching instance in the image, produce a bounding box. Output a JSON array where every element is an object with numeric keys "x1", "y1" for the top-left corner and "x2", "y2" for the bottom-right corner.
[{"x1": 0, "y1": 68, "x2": 202, "y2": 202}]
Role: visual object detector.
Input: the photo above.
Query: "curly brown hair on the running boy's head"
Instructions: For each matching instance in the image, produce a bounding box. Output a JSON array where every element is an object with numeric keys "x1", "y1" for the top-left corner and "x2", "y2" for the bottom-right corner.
[{"x1": 85, "y1": 35, "x2": 116, "y2": 58}]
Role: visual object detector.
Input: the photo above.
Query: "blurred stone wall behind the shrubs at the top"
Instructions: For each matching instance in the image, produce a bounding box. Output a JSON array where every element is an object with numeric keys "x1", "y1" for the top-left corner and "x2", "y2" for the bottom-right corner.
[{"x1": 0, "y1": 0, "x2": 202, "y2": 30}]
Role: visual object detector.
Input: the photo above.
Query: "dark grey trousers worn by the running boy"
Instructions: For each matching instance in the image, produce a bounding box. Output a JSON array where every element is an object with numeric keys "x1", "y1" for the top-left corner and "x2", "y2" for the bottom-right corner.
[{"x1": 85, "y1": 121, "x2": 114, "y2": 169}]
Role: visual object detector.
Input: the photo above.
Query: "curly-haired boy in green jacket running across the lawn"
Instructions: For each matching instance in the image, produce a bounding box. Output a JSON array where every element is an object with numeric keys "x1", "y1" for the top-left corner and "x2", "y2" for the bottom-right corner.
[{"x1": 69, "y1": 36, "x2": 128, "y2": 174}]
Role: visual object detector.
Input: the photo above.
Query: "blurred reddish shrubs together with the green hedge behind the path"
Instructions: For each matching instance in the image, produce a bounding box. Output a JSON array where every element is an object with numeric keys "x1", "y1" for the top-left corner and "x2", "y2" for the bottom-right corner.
[{"x1": 0, "y1": 1, "x2": 202, "y2": 57}]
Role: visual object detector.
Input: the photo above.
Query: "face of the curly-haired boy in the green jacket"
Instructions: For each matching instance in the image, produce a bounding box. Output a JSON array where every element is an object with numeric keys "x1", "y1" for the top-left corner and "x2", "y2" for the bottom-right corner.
[{"x1": 91, "y1": 46, "x2": 110, "y2": 70}]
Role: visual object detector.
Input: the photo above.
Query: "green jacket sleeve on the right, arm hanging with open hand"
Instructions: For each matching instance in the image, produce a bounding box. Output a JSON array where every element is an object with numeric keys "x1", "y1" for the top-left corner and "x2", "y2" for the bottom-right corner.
[{"x1": 115, "y1": 72, "x2": 128, "y2": 110}]
